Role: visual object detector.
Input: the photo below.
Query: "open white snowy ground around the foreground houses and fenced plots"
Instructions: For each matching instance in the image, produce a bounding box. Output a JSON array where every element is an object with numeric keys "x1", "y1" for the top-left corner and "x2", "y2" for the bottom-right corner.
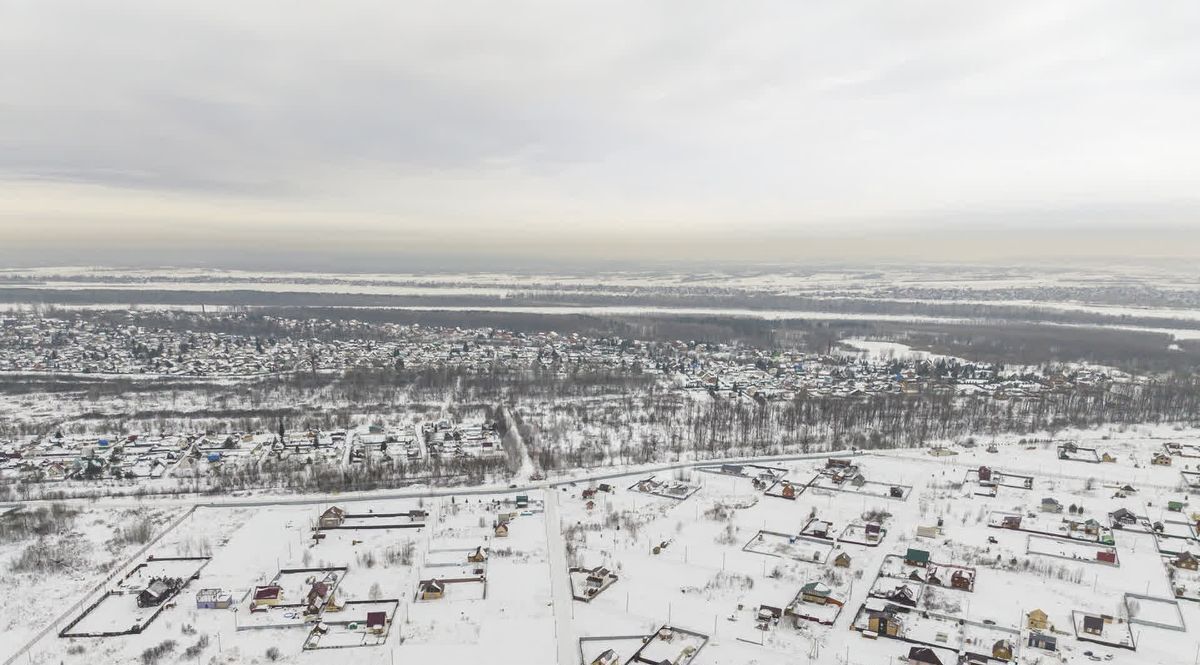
[{"x1": 4, "y1": 426, "x2": 1200, "y2": 665}]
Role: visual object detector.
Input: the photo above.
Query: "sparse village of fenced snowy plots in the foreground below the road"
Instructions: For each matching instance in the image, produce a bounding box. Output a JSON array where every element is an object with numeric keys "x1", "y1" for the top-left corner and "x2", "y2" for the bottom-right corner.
[{"x1": 7, "y1": 423, "x2": 1200, "y2": 665}]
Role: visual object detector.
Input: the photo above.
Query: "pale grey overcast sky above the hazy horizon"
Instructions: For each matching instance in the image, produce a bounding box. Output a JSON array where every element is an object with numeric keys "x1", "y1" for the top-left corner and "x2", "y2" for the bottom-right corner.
[{"x1": 0, "y1": 0, "x2": 1200, "y2": 268}]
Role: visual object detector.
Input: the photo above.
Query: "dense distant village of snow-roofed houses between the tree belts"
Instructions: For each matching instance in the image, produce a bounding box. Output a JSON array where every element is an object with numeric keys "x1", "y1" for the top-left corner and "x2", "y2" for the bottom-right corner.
[{"x1": 0, "y1": 310, "x2": 1113, "y2": 401}]
